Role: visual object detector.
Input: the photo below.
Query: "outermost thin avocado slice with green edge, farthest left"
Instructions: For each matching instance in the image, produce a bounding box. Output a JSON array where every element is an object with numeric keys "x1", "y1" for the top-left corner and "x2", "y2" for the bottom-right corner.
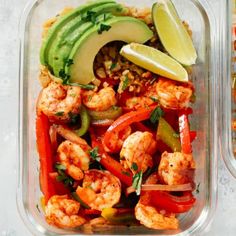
[{"x1": 40, "y1": 0, "x2": 115, "y2": 65}]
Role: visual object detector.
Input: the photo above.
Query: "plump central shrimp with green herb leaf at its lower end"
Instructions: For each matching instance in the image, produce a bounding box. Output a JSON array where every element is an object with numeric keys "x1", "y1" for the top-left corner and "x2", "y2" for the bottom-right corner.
[{"x1": 120, "y1": 131, "x2": 156, "y2": 174}]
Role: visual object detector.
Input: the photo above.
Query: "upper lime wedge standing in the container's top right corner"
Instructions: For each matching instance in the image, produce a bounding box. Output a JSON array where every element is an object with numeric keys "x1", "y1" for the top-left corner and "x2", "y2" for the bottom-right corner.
[{"x1": 152, "y1": 0, "x2": 197, "y2": 66}]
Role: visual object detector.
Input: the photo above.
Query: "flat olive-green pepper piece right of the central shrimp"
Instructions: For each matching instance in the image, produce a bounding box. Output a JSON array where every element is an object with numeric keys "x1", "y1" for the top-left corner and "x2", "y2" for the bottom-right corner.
[{"x1": 157, "y1": 117, "x2": 181, "y2": 152}]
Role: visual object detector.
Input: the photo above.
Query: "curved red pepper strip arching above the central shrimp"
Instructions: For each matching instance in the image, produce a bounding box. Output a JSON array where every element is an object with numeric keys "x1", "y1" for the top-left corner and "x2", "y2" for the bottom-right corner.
[{"x1": 104, "y1": 105, "x2": 156, "y2": 150}]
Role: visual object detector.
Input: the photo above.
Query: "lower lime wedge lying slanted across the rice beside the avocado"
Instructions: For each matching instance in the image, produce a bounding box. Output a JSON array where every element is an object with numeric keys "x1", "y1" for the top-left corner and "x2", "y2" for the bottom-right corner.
[{"x1": 120, "y1": 43, "x2": 188, "y2": 82}]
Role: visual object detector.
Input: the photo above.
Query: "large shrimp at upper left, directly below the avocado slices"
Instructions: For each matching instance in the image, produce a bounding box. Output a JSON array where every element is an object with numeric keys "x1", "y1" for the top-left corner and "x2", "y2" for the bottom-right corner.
[{"x1": 38, "y1": 82, "x2": 81, "y2": 122}]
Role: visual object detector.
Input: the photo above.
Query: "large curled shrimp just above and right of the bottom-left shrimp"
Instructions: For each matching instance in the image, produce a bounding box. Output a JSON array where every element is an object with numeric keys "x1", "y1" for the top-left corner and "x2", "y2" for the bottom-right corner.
[{"x1": 76, "y1": 170, "x2": 121, "y2": 211}]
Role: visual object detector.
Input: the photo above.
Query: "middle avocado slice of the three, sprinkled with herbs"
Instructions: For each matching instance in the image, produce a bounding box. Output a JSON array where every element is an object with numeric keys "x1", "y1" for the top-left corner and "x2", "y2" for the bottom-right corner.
[{"x1": 48, "y1": 3, "x2": 125, "y2": 76}]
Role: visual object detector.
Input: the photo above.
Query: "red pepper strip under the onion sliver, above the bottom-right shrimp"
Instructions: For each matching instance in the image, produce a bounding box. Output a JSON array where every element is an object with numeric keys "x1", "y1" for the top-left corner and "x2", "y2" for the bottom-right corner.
[{"x1": 150, "y1": 191, "x2": 196, "y2": 213}]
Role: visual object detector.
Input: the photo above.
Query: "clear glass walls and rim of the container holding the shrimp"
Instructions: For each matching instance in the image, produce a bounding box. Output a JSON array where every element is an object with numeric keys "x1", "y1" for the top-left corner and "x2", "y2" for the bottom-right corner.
[{"x1": 17, "y1": 0, "x2": 222, "y2": 235}]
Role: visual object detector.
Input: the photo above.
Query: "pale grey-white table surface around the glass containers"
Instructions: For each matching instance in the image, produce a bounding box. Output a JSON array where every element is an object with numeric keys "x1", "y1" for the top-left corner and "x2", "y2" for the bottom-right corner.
[{"x1": 0, "y1": 0, "x2": 236, "y2": 236}]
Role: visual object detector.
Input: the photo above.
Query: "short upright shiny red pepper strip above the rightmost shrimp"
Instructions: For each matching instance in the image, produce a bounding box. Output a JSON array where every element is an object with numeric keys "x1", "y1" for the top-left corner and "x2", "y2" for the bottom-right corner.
[{"x1": 179, "y1": 111, "x2": 192, "y2": 154}]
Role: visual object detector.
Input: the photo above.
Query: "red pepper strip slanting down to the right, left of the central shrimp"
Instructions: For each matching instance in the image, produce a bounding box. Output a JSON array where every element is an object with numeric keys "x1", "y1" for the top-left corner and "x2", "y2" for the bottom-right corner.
[{"x1": 90, "y1": 130, "x2": 133, "y2": 186}]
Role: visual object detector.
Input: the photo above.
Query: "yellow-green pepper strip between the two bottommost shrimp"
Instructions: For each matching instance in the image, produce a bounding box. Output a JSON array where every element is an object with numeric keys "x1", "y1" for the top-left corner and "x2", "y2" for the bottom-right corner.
[{"x1": 101, "y1": 208, "x2": 135, "y2": 223}]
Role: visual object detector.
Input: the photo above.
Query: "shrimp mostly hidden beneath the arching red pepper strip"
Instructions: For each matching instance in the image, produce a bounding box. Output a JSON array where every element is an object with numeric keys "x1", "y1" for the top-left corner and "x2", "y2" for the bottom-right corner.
[{"x1": 103, "y1": 126, "x2": 132, "y2": 153}]
